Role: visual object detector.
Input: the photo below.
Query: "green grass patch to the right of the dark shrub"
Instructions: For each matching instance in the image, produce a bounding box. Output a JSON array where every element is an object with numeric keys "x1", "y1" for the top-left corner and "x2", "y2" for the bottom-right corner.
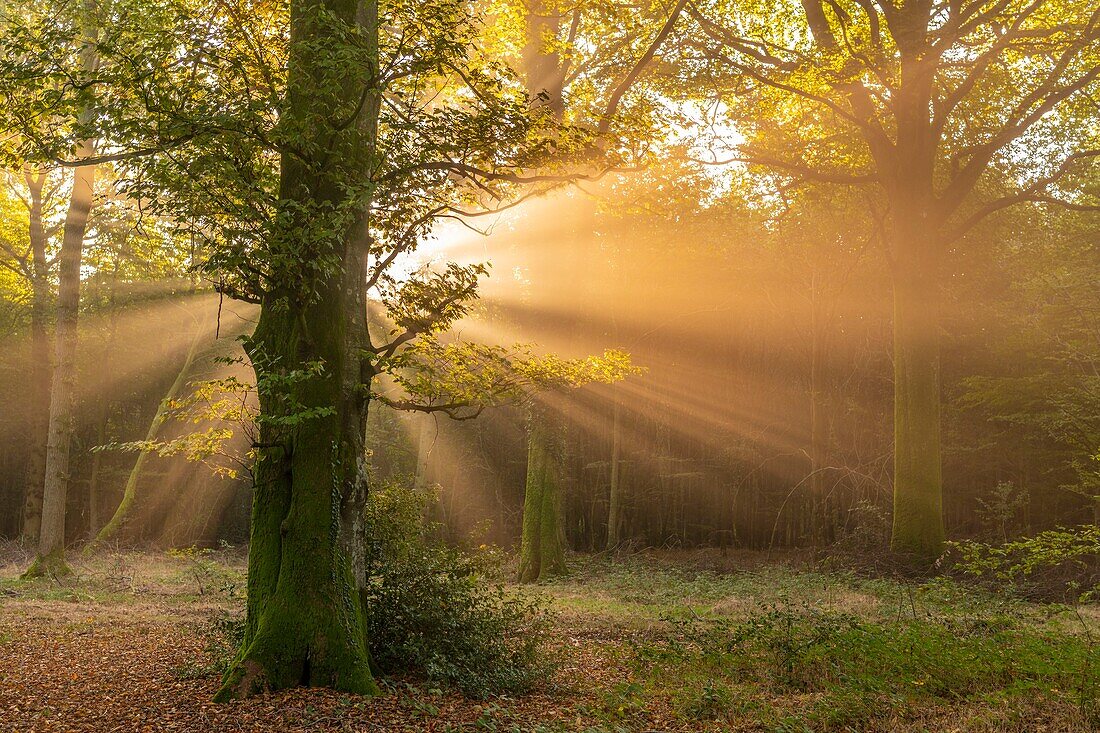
[{"x1": 530, "y1": 557, "x2": 1100, "y2": 731}]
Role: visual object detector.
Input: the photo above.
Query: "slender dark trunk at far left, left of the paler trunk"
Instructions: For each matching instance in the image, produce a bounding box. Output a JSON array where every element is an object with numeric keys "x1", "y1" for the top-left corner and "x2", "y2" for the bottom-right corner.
[{"x1": 22, "y1": 169, "x2": 52, "y2": 547}]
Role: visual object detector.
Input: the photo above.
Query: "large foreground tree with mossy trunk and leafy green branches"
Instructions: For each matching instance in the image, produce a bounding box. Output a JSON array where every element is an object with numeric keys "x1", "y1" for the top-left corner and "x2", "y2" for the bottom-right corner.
[{"x1": 124, "y1": 0, "x2": 602, "y2": 699}]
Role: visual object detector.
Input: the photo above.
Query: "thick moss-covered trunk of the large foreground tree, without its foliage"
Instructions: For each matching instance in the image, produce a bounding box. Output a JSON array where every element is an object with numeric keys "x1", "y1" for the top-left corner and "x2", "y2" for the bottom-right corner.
[{"x1": 217, "y1": 0, "x2": 378, "y2": 700}]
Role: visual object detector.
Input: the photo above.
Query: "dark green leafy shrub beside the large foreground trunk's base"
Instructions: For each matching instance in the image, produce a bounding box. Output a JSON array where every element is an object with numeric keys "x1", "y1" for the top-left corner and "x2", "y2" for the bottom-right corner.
[{"x1": 365, "y1": 483, "x2": 547, "y2": 697}]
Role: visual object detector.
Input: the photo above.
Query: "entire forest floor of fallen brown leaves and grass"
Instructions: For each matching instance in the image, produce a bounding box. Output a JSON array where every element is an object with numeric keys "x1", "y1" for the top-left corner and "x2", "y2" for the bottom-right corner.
[{"x1": 0, "y1": 546, "x2": 1100, "y2": 733}]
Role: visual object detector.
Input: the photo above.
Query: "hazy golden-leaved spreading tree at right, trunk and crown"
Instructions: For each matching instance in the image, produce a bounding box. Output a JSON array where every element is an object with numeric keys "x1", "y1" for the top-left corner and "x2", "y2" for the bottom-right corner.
[{"x1": 684, "y1": 0, "x2": 1100, "y2": 560}]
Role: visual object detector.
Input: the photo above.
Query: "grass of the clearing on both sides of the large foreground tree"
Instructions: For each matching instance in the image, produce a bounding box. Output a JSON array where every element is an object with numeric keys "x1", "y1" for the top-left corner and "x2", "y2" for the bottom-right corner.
[{"x1": 0, "y1": 541, "x2": 1100, "y2": 733}]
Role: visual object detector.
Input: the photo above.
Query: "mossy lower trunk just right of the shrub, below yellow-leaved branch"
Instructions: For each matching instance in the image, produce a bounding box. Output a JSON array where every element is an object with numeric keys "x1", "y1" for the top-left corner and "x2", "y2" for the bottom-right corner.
[{"x1": 518, "y1": 409, "x2": 565, "y2": 583}]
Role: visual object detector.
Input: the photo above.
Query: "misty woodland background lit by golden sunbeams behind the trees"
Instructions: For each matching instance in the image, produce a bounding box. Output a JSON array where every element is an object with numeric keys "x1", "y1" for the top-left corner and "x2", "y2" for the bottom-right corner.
[{"x1": 0, "y1": 162, "x2": 1100, "y2": 550}]
